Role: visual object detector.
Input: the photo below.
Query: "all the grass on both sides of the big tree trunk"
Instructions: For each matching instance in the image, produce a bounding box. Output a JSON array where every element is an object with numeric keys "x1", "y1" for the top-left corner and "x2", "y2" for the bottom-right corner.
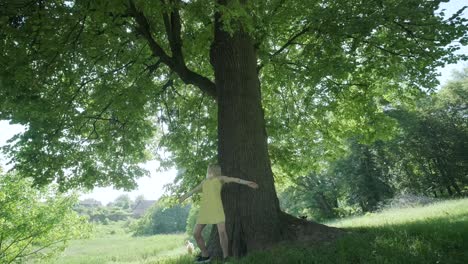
[{"x1": 41, "y1": 199, "x2": 468, "y2": 264}]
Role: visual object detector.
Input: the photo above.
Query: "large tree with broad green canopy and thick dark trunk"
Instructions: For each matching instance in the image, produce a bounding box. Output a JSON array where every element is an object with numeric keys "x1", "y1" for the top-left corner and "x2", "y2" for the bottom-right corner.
[{"x1": 0, "y1": 0, "x2": 468, "y2": 256}]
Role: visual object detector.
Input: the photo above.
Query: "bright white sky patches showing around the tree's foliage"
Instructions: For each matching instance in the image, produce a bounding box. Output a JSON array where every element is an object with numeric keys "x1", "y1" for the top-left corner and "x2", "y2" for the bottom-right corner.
[{"x1": 0, "y1": 0, "x2": 468, "y2": 204}]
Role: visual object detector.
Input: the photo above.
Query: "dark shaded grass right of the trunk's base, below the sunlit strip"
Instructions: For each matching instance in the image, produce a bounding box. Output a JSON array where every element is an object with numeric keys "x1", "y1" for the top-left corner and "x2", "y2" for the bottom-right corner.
[{"x1": 160, "y1": 212, "x2": 468, "y2": 264}]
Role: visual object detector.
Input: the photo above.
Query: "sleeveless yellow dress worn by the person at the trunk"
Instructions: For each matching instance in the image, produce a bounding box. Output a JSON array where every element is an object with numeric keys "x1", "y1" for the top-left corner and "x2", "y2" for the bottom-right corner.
[{"x1": 197, "y1": 177, "x2": 225, "y2": 224}]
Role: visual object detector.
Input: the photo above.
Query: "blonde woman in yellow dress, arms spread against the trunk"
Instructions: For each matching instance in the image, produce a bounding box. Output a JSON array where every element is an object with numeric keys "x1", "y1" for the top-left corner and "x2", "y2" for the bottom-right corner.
[{"x1": 179, "y1": 164, "x2": 258, "y2": 263}]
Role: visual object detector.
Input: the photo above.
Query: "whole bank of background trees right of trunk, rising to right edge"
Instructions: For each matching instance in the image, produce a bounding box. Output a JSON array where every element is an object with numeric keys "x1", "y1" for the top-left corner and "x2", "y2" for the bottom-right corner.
[{"x1": 279, "y1": 68, "x2": 468, "y2": 220}]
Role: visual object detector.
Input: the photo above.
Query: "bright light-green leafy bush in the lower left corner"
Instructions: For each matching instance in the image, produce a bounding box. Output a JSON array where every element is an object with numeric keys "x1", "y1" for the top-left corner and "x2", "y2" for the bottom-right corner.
[{"x1": 0, "y1": 170, "x2": 89, "y2": 263}]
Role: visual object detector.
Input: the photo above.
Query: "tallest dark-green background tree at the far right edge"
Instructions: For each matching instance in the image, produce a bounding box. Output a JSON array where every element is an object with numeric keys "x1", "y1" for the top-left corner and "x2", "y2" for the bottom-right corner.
[{"x1": 388, "y1": 69, "x2": 468, "y2": 197}]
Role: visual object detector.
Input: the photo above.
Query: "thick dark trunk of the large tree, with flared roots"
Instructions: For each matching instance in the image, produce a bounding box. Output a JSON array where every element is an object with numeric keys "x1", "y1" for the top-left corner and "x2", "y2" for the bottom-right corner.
[{"x1": 208, "y1": 1, "x2": 342, "y2": 256}]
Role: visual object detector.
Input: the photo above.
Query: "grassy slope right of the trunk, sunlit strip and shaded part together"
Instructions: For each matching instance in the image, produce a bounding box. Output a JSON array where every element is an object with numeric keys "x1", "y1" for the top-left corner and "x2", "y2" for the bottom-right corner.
[{"x1": 163, "y1": 199, "x2": 468, "y2": 264}]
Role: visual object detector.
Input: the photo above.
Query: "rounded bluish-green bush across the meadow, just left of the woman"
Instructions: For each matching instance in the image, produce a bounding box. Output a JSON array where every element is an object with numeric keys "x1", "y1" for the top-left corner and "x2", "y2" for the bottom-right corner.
[{"x1": 134, "y1": 199, "x2": 190, "y2": 236}]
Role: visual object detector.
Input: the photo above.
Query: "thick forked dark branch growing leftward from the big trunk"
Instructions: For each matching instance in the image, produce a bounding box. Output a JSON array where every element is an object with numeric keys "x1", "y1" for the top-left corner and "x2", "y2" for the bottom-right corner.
[{"x1": 129, "y1": 0, "x2": 217, "y2": 99}]
